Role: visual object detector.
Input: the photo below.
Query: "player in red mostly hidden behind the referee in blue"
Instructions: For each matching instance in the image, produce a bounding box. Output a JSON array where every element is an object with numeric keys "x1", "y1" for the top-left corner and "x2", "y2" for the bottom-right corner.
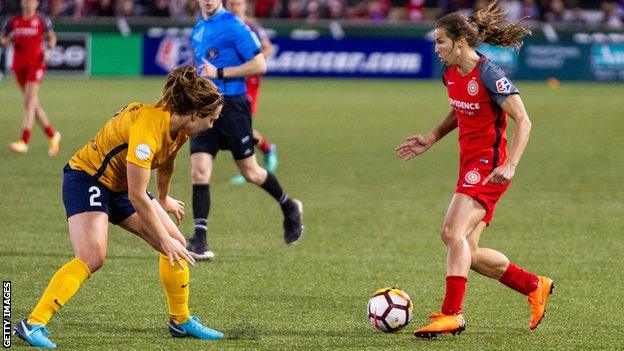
[{"x1": 226, "y1": 0, "x2": 277, "y2": 184}]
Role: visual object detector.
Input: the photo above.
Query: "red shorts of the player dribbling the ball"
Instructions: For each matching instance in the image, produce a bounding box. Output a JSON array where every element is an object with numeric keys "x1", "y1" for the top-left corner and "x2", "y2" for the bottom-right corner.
[{"x1": 455, "y1": 165, "x2": 511, "y2": 225}]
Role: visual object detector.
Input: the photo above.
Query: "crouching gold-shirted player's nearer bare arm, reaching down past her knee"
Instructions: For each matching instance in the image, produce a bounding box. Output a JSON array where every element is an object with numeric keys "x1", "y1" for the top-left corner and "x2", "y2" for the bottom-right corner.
[{"x1": 128, "y1": 162, "x2": 195, "y2": 269}]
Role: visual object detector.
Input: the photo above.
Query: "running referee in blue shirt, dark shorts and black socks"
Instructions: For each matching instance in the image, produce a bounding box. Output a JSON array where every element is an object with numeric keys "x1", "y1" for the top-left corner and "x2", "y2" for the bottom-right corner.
[{"x1": 189, "y1": 0, "x2": 303, "y2": 260}]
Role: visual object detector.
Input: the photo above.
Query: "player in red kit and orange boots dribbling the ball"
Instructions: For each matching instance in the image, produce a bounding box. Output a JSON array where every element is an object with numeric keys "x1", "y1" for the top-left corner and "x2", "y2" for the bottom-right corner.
[{"x1": 396, "y1": 1, "x2": 554, "y2": 338}]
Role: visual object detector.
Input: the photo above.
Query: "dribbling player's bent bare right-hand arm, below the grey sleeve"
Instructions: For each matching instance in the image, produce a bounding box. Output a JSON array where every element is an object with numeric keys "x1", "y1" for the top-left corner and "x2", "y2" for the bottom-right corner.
[{"x1": 483, "y1": 94, "x2": 531, "y2": 184}]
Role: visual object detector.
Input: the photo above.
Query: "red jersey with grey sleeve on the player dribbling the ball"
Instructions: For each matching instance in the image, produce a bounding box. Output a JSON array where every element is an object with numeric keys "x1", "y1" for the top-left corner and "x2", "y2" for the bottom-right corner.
[{"x1": 444, "y1": 56, "x2": 518, "y2": 170}]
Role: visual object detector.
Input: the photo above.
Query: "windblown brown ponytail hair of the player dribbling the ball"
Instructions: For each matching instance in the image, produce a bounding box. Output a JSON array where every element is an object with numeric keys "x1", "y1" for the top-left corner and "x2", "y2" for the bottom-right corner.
[{"x1": 435, "y1": 0, "x2": 531, "y2": 50}]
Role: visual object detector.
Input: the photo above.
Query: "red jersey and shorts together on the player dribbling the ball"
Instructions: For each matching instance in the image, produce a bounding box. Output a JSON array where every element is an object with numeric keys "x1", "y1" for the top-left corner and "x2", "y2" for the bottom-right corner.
[{"x1": 444, "y1": 54, "x2": 518, "y2": 225}]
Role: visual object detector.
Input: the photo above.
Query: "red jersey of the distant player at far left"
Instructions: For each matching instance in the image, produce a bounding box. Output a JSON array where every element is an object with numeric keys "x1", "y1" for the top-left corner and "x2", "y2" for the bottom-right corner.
[{"x1": 2, "y1": 12, "x2": 52, "y2": 69}]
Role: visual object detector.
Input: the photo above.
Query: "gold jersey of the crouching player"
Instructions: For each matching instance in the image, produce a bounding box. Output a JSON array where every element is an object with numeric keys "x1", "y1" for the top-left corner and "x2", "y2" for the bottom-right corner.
[{"x1": 69, "y1": 102, "x2": 188, "y2": 191}]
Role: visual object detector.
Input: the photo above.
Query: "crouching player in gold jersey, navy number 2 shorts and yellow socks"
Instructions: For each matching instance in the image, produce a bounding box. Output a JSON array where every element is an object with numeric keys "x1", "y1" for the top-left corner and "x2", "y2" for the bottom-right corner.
[{"x1": 15, "y1": 66, "x2": 223, "y2": 348}]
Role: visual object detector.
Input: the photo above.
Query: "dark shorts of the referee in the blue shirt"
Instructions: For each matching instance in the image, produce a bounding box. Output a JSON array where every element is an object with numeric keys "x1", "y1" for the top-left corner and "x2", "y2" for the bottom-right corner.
[{"x1": 190, "y1": 95, "x2": 254, "y2": 160}]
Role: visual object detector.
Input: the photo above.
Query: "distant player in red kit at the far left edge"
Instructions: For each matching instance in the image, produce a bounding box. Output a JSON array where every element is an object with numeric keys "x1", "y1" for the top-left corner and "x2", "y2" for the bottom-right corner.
[{"x1": 0, "y1": 0, "x2": 61, "y2": 156}]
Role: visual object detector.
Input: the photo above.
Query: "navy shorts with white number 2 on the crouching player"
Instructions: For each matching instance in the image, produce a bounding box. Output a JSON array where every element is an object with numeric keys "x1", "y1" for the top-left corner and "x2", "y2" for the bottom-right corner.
[{"x1": 63, "y1": 164, "x2": 154, "y2": 225}]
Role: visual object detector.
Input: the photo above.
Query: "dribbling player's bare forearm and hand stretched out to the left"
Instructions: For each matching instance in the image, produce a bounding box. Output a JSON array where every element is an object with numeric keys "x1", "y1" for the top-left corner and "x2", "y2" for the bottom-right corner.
[{"x1": 395, "y1": 110, "x2": 457, "y2": 161}]
